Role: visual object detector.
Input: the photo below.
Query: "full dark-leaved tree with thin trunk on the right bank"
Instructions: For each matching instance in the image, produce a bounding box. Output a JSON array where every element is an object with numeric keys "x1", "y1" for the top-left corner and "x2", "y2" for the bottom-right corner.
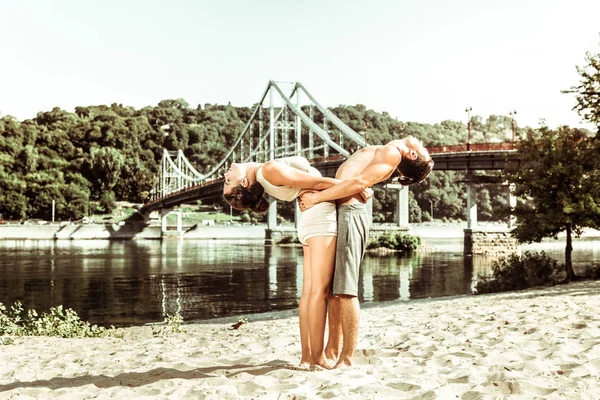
[{"x1": 505, "y1": 126, "x2": 600, "y2": 281}]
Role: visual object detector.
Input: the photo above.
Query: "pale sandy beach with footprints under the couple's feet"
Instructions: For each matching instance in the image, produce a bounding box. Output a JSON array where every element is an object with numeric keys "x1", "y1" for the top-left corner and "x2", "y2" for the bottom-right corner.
[{"x1": 0, "y1": 282, "x2": 600, "y2": 399}]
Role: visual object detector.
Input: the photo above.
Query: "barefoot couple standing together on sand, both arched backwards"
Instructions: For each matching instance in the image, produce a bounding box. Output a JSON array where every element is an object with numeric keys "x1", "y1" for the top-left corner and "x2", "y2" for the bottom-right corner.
[{"x1": 223, "y1": 136, "x2": 433, "y2": 369}]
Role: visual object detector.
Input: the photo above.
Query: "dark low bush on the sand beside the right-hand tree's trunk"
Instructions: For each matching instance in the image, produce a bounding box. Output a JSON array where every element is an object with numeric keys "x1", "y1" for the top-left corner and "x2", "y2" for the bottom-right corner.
[{"x1": 475, "y1": 251, "x2": 564, "y2": 294}]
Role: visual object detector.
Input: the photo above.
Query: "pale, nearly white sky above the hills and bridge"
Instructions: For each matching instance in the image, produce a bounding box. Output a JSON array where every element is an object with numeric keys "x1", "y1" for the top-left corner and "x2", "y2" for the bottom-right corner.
[{"x1": 0, "y1": 0, "x2": 600, "y2": 128}]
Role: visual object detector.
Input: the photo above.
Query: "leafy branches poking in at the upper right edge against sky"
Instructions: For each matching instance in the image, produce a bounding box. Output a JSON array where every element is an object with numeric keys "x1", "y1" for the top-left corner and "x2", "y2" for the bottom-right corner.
[{"x1": 563, "y1": 43, "x2": 600, "y2": 135}]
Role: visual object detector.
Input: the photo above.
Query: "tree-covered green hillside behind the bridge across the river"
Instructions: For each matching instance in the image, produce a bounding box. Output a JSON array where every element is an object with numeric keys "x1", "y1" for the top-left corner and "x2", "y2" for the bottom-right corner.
[{"x1": 0, "y1": 99, "x2": 548, "y2": 222}]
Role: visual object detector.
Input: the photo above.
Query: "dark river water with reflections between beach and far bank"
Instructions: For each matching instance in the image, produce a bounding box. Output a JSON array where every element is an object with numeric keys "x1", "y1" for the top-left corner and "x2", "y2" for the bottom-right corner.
[{"x1": 0, "y1": 240, "x2": 600, "y2": 326}]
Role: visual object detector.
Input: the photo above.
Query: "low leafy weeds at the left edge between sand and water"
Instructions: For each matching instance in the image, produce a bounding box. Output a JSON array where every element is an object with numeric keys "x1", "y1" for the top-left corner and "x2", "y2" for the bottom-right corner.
[{"x1": 0, "y1": 302, "x2": 120, "y2": 344}]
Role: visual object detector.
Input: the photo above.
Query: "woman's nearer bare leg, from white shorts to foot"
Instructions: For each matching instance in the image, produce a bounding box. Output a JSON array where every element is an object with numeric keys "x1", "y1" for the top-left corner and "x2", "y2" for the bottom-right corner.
[{"x1": 306, "y1": 236, "x2": 336, "y2": 368}]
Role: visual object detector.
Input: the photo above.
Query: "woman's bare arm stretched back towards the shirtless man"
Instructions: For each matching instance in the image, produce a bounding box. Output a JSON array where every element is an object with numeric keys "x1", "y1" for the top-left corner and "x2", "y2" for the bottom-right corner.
[{"x1": 262, "y1": 161, "x2": 341, "y2": 190}]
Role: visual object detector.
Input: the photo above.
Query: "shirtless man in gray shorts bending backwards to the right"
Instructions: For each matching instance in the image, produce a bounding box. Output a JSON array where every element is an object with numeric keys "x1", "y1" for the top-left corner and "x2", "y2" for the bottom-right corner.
[{"x1": 299, "y1": 136, "x2": 433, "y2": 368}]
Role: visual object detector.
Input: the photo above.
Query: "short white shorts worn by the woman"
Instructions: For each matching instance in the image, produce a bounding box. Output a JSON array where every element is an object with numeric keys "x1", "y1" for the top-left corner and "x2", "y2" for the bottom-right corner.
[{"x1": 298, "y1": 202, "x2": 337, "y2": 246}]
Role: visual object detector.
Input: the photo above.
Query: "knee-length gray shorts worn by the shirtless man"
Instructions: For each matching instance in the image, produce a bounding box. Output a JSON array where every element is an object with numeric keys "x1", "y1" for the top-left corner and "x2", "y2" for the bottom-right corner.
[{"x1": 333, "y1": 204, "x2": 369, "y2": 296}]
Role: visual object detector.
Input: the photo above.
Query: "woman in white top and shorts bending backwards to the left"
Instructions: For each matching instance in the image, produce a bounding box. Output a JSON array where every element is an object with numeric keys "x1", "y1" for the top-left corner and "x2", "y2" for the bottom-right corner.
[{"x1": 223, "y1": 156, "x2": 372, "y2": 368}]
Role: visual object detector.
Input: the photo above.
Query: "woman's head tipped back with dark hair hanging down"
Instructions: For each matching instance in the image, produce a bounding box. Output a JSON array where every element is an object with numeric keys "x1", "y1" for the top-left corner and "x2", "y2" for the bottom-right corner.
[{"x1": 223, "y1": 163, "x2": 269, "y2": 213}]
